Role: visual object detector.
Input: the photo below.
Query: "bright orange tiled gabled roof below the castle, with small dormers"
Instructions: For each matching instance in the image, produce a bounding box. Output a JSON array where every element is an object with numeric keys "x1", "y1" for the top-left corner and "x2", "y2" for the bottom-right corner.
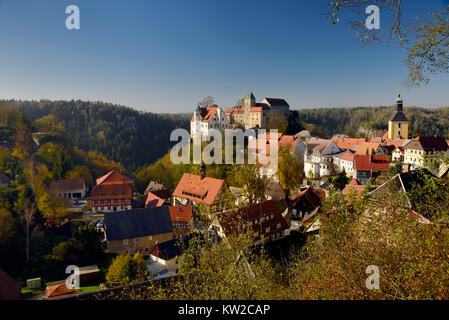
[{"x1": 173, "y1": 173, "x2": 224, "y2": 206}]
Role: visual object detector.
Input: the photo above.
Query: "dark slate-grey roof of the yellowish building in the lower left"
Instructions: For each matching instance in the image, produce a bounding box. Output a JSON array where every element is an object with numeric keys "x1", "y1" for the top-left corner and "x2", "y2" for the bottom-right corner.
[{"x1": 104, "y1": 206, "x2": 173, "y2": 241}]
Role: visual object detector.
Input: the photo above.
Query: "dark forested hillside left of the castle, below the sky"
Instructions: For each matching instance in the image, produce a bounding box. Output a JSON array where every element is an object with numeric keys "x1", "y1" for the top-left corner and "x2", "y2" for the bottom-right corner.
[{"x1": 0, "y1": 100, "x2": 190, "y2": 170}]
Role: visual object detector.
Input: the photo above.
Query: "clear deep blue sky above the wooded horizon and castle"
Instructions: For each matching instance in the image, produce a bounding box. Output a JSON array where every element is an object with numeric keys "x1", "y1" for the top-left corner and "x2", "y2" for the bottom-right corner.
[{"x1": 0, "y1": 0, "x2": 449, "y2": 112}]
